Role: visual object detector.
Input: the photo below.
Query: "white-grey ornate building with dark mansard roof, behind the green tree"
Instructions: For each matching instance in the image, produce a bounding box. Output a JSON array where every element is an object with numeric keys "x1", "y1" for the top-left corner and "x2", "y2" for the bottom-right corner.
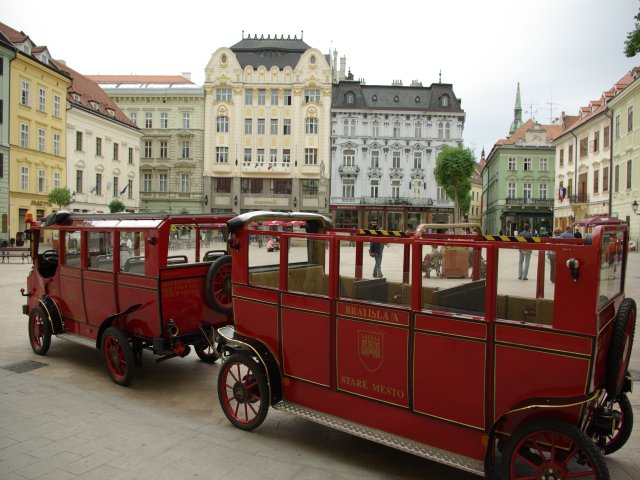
[{"x1": 331, "y1": 76, "x2": 465, "y2": 230}]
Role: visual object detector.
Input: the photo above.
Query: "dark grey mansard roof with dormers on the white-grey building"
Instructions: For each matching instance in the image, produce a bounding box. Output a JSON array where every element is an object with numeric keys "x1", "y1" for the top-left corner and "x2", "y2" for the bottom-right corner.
[{"x1": 331, "y1": 80, "x2": 464, "y2": 113}]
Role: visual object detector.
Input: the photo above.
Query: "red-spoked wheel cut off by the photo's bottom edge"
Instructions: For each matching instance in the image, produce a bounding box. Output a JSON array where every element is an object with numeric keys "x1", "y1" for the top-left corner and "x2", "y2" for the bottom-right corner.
[{"x1": 500, "y1": 419, "x2": 610, "y2": 480}]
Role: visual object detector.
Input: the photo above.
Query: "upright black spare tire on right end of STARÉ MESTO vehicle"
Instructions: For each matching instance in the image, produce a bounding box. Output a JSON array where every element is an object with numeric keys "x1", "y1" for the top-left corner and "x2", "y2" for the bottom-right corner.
[{"x1": 605, "y1": 298, "x2": 636, "y2": 398}]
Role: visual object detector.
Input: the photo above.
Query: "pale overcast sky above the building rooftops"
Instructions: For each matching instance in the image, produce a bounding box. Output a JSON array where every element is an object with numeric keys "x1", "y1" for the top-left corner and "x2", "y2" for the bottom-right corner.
[{"x1": 0, "y1": 0, "x2": 640, "y2": 157}]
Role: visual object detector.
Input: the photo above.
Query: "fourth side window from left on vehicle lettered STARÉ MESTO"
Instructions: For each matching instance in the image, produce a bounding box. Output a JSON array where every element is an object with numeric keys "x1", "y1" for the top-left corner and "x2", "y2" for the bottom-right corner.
[{"x1": 421, "y1": 244, "x2": 487, "y2": 317}]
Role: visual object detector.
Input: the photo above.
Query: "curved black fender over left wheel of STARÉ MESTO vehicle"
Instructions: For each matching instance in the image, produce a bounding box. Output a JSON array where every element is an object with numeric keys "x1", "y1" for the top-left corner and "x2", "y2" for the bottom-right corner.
[{"x1": 218, "y1": 325, "x2": 282, "y2": 405}]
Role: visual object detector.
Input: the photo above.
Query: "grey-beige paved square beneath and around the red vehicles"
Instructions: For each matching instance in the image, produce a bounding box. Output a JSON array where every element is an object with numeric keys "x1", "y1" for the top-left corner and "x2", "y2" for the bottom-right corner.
[{"x1": 0, "y1": 249, "x2": 640, "y2": 480}]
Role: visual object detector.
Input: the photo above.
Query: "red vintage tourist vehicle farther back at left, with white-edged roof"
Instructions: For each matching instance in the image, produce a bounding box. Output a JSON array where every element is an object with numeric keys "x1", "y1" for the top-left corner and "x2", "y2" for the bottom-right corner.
[{"x1": 22, "y1": 211, "x2": 238, "y2": 385}]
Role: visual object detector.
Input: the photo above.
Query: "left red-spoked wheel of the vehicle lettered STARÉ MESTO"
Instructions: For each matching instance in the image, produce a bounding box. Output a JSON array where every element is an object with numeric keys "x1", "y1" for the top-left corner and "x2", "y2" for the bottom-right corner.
[{"x1": 218, "y1": 353, "x2": 269, "y2": 430}]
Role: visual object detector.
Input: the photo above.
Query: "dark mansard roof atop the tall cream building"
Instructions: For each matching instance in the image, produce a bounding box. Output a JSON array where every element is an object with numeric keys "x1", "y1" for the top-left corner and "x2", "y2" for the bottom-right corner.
[{"x1": 231, "y1": 35, "x2": 311, "y2": 70}]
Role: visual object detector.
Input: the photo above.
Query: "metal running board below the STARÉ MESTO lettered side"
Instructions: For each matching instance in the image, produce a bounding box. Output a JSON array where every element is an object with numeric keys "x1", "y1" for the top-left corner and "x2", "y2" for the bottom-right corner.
[{"x1": 272, "y1": 401, "x2": 484, "y2": 476}]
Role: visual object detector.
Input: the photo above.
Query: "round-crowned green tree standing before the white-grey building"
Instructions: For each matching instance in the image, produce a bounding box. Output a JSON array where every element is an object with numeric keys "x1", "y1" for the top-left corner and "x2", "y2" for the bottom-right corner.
[{"x1": 434, "y1": 145, "x2": 476, "y2": 222}]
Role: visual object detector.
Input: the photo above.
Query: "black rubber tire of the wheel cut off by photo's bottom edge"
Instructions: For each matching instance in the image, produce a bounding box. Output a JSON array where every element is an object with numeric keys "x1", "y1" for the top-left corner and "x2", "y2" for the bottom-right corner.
[{"x1": 500, "y1": 418, "x2": 611, "y2": 480}]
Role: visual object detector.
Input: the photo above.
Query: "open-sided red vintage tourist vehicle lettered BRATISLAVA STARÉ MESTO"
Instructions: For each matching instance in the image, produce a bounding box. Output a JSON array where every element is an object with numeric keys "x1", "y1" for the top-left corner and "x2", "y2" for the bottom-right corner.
[{"x1": 218, "y1": 212, "x2": 636, "y2": 480}]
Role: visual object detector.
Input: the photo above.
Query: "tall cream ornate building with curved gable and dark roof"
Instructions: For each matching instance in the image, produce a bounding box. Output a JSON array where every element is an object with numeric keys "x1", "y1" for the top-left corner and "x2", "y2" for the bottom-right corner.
[{"x1": 204, "y1": 36, "x2": 332, "y2": 213}]
